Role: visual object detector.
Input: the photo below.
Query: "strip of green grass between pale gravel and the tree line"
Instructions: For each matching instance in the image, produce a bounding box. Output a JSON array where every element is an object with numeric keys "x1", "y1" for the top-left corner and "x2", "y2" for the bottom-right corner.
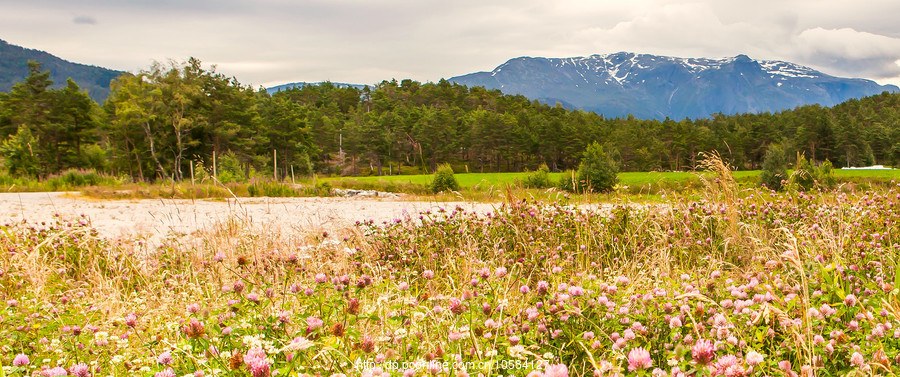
[{"x1": 0, "y1": 169, "x2": 900, "y2": 201}]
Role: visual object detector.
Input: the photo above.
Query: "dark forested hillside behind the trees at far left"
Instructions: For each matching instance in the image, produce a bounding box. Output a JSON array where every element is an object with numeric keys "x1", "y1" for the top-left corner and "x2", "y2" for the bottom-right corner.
[{"x1": 0, "y1": 39, "x2": 122, "y2": 102}]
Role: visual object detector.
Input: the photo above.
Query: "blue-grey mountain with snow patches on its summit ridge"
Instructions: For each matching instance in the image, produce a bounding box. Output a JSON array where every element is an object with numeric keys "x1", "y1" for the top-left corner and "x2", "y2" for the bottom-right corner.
[{"x1": 450, "y1": 52, "x2": 900, "y2": 119}]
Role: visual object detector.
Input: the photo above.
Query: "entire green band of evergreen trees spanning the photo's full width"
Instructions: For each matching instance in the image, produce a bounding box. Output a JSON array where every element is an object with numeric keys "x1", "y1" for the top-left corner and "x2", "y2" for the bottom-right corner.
[{"x1": 0, "y1": 59, "x2": 900, "y2": 180}]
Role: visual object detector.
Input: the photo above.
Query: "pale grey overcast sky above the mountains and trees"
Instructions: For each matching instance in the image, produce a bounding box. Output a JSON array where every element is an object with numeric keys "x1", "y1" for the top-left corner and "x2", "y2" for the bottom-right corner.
[{"x1": 0, "y1": 0, "x2": 900, "y2": 86}]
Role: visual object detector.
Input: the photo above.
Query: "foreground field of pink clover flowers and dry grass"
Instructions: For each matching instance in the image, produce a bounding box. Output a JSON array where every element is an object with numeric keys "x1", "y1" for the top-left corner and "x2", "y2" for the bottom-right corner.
[{"x1": 0, "y1": 169, "x2": 900, "y2": 377}]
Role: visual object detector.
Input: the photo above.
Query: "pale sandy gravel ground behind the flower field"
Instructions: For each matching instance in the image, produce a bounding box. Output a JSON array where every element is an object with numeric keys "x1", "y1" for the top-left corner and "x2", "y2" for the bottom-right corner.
[{"x1": 0, "y1": 192, "x2": 495, "y2": 240}]
